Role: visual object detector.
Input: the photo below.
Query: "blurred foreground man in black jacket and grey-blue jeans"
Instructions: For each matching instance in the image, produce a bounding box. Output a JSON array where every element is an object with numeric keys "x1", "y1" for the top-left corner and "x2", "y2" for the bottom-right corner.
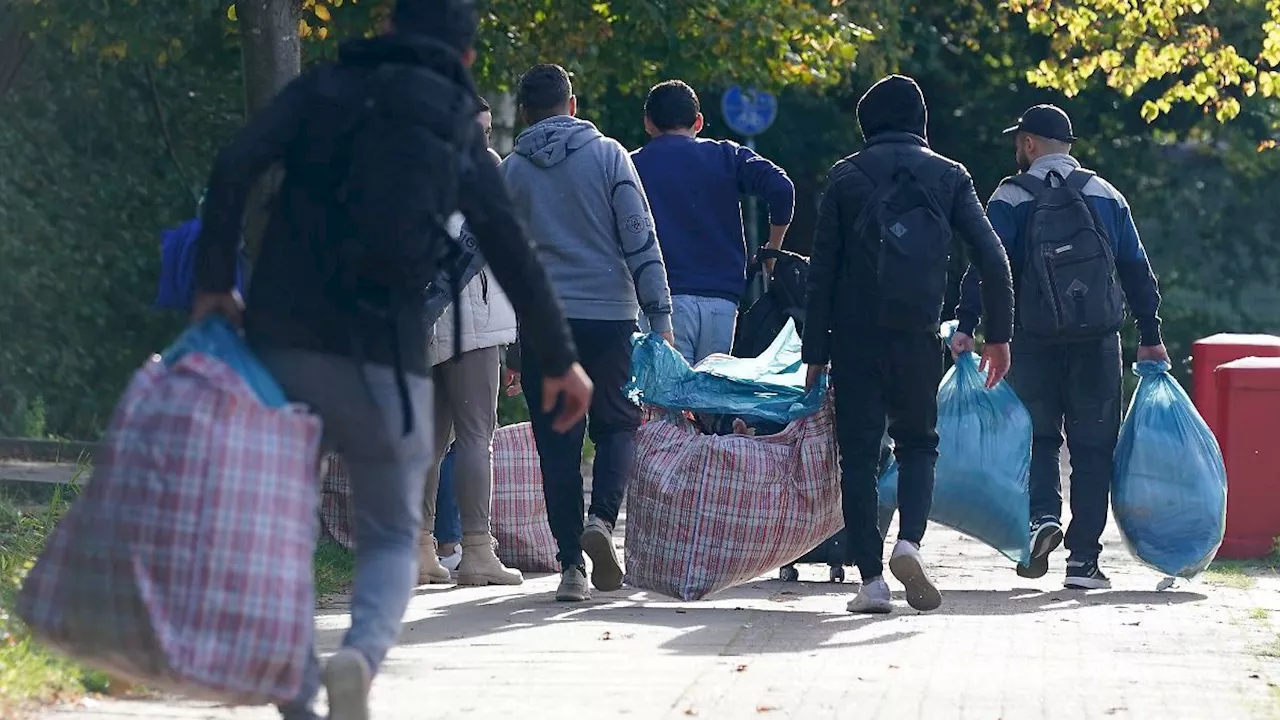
[{"x1": 192, "y1": 0, "x2": 590, "y2": 720}]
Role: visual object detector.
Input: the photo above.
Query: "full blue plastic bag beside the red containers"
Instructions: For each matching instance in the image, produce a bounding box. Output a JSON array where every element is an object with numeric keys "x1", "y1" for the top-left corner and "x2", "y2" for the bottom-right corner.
[{"x1": 1111, "y1": 361, "x2": 1226, "y2": 578}]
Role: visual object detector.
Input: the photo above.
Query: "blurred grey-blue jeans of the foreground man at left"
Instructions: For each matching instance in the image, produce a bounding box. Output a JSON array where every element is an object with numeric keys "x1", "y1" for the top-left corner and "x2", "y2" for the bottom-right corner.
[{"x1": 255, "y1": 348, "x2": 431, "y2": 720}]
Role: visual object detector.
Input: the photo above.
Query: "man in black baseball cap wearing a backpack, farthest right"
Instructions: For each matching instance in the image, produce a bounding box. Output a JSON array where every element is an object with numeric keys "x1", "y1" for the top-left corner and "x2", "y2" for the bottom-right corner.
[{"x1": 951, "y1": 105, "x2": 1169, "y2": 589}]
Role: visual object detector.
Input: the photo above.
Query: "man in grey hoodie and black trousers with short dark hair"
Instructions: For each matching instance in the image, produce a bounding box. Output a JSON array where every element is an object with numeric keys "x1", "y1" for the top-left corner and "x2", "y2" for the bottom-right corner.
[{"x1": 502, "y1": 65, "x2": 672, "y2": 601}]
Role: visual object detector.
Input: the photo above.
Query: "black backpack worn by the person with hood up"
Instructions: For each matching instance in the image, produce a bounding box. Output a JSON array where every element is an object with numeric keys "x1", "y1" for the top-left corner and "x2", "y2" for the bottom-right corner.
[{"x1": 854, "y1": 163, "x2": 952, "y2": 331}]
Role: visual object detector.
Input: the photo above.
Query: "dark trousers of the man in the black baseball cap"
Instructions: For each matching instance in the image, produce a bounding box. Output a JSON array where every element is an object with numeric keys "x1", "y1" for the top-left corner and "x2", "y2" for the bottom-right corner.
[{"x1": 1009, "y1": 334, "x2": 1121, "y2": 560}]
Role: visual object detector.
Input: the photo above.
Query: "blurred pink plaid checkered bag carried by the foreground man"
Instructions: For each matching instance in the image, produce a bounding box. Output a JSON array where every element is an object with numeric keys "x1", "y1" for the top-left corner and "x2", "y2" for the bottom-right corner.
[{"x1": 18, "y1": 352, "x2": 320, "y2": 705}]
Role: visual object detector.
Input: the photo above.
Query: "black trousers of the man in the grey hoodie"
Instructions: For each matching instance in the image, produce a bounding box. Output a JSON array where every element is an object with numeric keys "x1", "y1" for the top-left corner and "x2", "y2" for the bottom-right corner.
[{"x1": 521, "y1": 320, "x2": 640, "y2": 568}]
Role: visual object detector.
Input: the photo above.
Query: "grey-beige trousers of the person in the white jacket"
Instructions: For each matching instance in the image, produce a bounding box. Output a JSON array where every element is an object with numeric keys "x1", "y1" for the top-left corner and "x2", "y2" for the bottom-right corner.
[{"x1": 422, "y1": 347, "x2": 502, "y2": 536}]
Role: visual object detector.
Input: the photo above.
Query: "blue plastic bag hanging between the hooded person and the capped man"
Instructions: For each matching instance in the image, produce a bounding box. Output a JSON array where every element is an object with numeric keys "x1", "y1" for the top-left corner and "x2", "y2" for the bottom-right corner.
[{"x1": 880, "y1": 352, "x2": 1032, "y2": 565}]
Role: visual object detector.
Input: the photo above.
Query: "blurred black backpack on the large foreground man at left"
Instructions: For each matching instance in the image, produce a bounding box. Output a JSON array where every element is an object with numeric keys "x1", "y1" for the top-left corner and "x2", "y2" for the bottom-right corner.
[{"x1": 310, "y1": 63, "x2": 480, "y2": 433}]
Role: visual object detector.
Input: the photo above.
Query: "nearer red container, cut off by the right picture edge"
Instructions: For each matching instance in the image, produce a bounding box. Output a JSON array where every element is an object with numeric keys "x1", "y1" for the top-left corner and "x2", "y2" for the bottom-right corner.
[{"x1": 1215, "y1": 357, "x2": 1280, "y2": 560}]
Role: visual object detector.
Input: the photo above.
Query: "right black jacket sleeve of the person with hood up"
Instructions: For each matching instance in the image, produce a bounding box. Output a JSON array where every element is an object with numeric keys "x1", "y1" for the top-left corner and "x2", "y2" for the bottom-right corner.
[{"x1": 951, "y1": 167, "x2": 1014, "y2": 343}]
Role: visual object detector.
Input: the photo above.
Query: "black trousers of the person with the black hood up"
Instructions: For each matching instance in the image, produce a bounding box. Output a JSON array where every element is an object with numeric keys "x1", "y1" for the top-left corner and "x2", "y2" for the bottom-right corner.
[{"x1": 831, "y1": 328, "x2": 943, "y2": 582}]
